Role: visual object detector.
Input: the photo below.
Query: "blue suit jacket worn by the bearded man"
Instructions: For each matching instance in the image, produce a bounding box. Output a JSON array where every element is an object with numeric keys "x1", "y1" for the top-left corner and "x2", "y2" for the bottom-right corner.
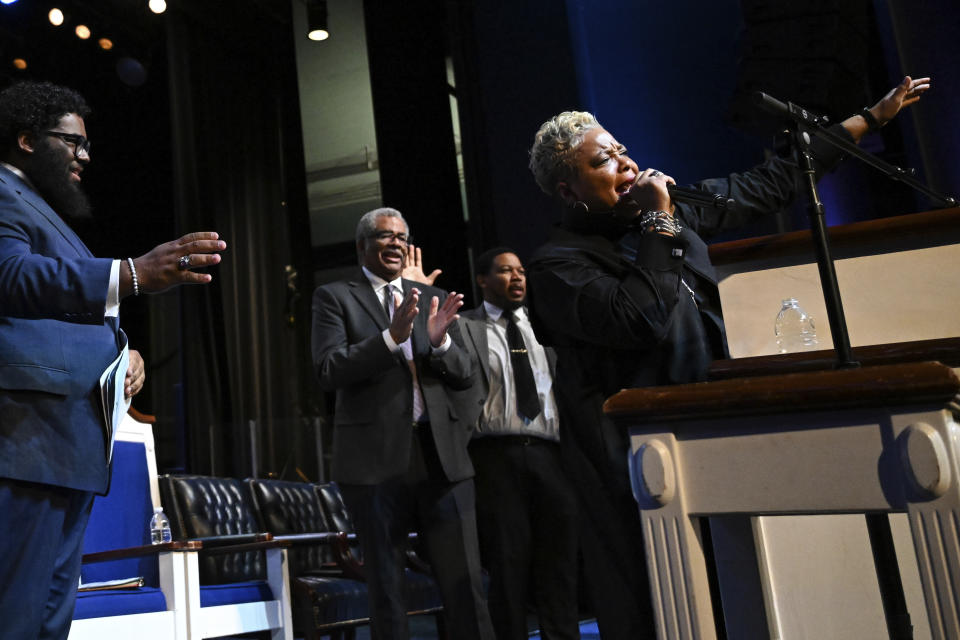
[{"x1": 0, "y1": 166, "x2": 119, "y2": 493}]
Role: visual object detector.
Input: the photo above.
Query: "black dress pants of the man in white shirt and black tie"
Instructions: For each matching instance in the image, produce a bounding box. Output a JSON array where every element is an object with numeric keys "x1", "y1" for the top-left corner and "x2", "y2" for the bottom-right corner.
[{"x1": 470, "y1": 436, "x2": 580, "y2": 640}]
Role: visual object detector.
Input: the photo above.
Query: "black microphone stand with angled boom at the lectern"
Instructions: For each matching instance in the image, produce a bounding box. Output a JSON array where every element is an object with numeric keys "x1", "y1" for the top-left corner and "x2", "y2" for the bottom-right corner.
[{"x1": 756, "y1": 92, "x2": 957, "y2": 640}]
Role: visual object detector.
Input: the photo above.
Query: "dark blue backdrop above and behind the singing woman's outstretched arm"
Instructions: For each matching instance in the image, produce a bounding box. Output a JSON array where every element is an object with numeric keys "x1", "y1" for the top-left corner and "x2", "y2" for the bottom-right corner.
[{"x1": 567, "y1": 0, "x2": 960, "y2": 228}]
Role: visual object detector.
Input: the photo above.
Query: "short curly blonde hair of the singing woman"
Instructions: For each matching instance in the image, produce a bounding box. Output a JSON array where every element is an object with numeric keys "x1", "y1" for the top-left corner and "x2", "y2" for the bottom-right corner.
[{"x1": 529, "y1": 111, "x2": 600, "y2": 195}]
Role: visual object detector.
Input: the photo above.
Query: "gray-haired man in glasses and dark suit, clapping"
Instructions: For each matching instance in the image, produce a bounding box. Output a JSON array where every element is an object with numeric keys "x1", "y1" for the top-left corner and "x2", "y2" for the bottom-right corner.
[{"x1": 313, "y1": 208, "x2": 493, "y2": 640}]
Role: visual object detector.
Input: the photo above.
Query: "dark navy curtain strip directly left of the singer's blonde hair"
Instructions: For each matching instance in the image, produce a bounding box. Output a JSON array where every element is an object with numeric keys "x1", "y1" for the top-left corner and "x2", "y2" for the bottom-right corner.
[{"x1": 445, "y1": 0, "x2": 583, "y2": 260}]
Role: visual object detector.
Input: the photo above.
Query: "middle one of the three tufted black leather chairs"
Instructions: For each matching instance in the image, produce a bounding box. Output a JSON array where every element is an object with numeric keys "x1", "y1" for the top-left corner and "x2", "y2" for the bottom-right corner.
[{"x1": 246, "y1": 479, "x2": 370, "y2": 640}]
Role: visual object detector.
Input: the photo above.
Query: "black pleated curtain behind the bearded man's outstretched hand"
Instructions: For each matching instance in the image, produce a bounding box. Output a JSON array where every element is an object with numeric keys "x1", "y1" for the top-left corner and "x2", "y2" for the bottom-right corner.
[{"x1": 151, "y1": 0, "x2": 316, "y2": 477}]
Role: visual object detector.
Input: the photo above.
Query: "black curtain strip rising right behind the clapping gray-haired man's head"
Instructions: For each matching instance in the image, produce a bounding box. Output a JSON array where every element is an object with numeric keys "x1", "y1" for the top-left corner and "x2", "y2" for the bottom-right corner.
[{"x1": 364, "y1": 0, "x2": 471, "y2": 292}]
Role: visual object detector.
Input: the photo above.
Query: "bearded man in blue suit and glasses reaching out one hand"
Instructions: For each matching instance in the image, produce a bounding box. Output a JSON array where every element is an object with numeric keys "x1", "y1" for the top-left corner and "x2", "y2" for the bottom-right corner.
[{"x1": 0, "y1": 82, "x2": 226, "y2": 639}]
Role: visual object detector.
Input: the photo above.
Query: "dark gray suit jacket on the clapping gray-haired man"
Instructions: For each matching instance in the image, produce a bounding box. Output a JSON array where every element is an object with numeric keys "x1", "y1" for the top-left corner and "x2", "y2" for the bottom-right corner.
[{"x1": 313, "y1": 269, "x2": 480, "y2": 485}]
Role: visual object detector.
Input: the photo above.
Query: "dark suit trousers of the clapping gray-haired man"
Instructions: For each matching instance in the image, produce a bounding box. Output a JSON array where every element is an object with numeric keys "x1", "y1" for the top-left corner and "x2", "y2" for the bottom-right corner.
[{"x1": 340, "y1": 425, "x2": 494, "y2": 640}]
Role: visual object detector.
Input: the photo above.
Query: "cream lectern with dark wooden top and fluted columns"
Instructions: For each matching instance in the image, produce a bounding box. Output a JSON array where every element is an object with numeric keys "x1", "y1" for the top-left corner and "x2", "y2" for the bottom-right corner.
[{"x1": 605, "y1": 209, "x2": 960, "y2": 640}]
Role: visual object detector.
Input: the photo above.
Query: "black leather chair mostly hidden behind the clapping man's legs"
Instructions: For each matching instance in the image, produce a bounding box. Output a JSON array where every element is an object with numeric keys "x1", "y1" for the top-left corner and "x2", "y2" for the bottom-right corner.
[{"x1": 314, "y1": 482, "x2": 447, "y2": 638}]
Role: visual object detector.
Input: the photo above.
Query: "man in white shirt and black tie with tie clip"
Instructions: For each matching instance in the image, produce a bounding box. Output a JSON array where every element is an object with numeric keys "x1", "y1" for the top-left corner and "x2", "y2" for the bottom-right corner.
[{"x1": 461, "y1": 247, "x2": 580, "y2": 640}]
